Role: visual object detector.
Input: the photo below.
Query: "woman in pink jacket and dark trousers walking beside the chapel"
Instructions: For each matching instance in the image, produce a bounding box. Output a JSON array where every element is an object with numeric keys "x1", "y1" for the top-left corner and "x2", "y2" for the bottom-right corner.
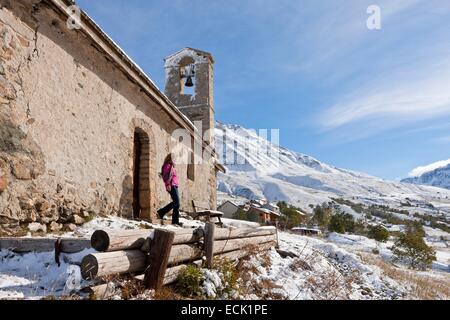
[{"x1": 158, "y1": 153, "x2": 181, "y2": 226}]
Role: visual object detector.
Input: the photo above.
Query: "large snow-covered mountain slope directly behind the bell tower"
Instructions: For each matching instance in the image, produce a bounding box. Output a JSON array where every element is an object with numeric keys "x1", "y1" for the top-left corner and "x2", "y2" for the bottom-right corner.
[{"x1": 216, "y1": 123, "x2": 450, "y2": 213}]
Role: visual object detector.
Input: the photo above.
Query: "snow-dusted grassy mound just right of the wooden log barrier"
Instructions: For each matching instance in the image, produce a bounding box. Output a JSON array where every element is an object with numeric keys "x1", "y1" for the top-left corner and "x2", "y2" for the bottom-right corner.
[{"x1": 239, "y1": 232, "x2": 405, "y2": 300}]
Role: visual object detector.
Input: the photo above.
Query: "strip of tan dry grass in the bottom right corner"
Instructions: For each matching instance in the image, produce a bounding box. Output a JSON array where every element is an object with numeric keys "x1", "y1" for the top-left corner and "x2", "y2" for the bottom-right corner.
[{"x1": 360, "y1": 253, "x2": 450, "y2": 300}]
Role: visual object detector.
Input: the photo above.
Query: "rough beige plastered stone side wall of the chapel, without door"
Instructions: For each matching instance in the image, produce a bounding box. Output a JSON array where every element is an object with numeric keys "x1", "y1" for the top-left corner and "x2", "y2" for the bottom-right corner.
[{"x1": 0, "y1": 0, "x2": 216, "y2": 235}]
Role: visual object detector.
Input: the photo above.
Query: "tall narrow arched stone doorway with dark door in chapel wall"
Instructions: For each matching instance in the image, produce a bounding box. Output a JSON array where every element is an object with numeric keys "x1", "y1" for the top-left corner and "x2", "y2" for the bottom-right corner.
[{"x1": 132, "y1": 119, "x2": 157, "y2": 221}]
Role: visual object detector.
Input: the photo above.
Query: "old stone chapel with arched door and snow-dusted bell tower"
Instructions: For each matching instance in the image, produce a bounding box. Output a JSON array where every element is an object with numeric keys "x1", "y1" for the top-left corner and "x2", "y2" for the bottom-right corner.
[{"x1": 0, "y1": 0, "x2": 223, "y2": 235}]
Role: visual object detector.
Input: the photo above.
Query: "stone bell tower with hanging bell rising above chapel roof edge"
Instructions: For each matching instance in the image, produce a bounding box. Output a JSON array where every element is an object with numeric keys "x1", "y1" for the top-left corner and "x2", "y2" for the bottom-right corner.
[{"x1": 164, "y1": 48, "x2": 214, "y2": 144}]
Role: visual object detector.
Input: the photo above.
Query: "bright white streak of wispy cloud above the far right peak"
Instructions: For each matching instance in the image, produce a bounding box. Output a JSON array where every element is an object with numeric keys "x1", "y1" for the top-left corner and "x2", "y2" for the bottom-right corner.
[{"x1": 320, "y1": 60, "x2": 450, "y2": 130}]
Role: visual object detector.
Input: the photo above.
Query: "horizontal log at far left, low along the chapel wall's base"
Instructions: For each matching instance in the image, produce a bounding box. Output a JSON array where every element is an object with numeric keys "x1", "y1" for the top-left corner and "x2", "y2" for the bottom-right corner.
[{"x1": 0, "y1": 238, "x2": 91, "y2": 253}]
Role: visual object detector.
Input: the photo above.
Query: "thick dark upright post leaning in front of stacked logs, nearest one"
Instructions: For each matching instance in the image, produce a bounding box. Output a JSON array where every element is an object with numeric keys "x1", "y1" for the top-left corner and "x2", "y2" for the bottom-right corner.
[{"x1": 144, "y1": 230, "x2": 175, "y2": 290}]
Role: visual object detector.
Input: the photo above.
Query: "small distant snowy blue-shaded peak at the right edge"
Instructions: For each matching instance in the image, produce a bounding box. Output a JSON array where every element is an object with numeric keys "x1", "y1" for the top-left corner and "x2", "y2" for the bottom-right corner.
[{"x1": 402, "y1": 160, "x2": 450, "y2": 189}]
